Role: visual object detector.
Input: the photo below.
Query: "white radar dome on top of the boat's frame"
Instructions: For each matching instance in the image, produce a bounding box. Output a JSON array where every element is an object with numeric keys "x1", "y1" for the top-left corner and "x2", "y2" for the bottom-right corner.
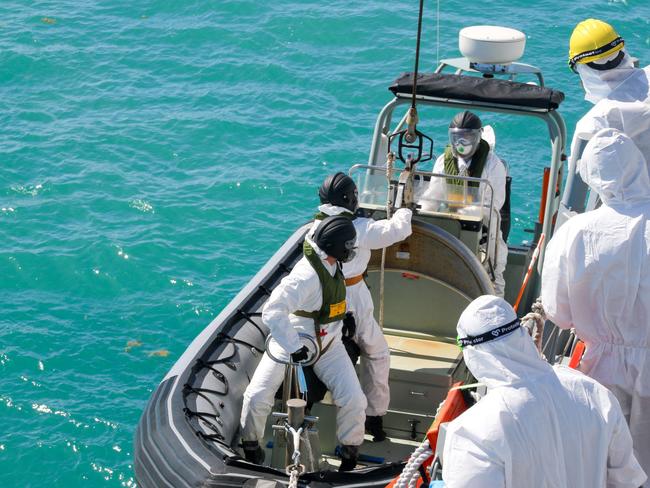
[{"x1": 458, "y1": 25, "x2": 526, "y2": 64}]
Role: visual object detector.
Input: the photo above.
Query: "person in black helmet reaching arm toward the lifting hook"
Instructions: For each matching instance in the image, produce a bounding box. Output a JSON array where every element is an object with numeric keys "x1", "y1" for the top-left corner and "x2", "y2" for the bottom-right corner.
[{"x1": 312, "y1": 172, "x2": 412, "y2": 442}]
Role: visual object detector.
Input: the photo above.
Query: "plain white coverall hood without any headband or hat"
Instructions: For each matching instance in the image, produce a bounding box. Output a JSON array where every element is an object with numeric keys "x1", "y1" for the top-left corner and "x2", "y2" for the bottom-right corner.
[{"x1": 578, "y1": 128, "x2": 650, "y2": 207}]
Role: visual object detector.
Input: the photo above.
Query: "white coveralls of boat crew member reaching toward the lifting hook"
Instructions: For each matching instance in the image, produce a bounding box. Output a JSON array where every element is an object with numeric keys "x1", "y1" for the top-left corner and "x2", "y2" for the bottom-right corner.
[{"x1": 310, "y1": 203, "x2": 412, "y2": 416}]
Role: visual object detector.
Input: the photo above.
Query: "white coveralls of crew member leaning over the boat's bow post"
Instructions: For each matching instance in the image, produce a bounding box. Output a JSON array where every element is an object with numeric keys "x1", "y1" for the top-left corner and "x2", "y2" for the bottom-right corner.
[{"x1": 240, "y1": 238, "x2": 366, "y2": 446}]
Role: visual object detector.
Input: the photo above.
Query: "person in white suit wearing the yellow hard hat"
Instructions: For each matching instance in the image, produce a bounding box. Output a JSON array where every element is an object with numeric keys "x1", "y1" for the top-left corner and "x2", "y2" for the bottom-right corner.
[{"x1": 569, "y1": 19, "x2": 650, "y2": 175}]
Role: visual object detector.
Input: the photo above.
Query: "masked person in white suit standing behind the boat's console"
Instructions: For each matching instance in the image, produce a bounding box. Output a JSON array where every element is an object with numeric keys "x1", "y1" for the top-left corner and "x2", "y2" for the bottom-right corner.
[{"x1": 420, "y1": 110, "x2": 508, "y2": 297}]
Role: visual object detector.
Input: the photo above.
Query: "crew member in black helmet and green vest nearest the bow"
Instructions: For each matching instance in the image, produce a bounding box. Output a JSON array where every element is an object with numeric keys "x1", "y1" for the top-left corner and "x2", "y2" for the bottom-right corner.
[{"x1": 240, "y1": 216, "x2": 366, "y2": 471}]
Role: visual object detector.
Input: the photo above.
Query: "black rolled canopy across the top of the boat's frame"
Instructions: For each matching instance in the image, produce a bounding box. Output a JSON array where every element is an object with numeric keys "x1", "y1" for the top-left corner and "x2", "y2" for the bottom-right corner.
[{"x1": 389, "y1": 73, "x2": 564, "y2": 110}]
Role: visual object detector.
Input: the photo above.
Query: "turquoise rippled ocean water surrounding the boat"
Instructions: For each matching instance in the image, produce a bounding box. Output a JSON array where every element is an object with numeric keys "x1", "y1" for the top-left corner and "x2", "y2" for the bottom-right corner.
[{"x1": 0, "y1": 0, "x2": 650, "y2": 487}]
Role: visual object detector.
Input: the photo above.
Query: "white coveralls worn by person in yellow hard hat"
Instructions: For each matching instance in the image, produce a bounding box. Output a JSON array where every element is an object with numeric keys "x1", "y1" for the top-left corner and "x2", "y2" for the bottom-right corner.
[{"x1": 571, "y1": 53, "x2": 650, "y2": 172}]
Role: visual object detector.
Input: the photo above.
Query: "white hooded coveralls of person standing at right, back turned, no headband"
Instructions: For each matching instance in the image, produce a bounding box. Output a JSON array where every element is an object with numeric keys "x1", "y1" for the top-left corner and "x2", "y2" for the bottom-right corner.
[{"x1": 542, "y1": 129, "x2": 650, "y2": 473}]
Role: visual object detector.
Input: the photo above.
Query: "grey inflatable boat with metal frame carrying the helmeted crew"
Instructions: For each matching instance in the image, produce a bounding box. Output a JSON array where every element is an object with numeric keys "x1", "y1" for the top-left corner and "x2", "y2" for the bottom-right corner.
[{"x1": 134, "y1": 27, "x2": 577, "y2": 488}]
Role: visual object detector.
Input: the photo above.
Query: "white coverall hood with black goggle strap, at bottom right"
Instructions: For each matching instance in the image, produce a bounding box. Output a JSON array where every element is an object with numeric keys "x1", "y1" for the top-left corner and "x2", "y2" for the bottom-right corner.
[{"x1": 457, "y1": 295, "x2": 554, "y2": 389}]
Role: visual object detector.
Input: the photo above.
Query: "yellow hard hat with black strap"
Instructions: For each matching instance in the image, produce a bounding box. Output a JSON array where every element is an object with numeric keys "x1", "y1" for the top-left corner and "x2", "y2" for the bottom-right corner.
[{"x1": 569, "y1": 19, "x2": 625, "y2": 71}]
